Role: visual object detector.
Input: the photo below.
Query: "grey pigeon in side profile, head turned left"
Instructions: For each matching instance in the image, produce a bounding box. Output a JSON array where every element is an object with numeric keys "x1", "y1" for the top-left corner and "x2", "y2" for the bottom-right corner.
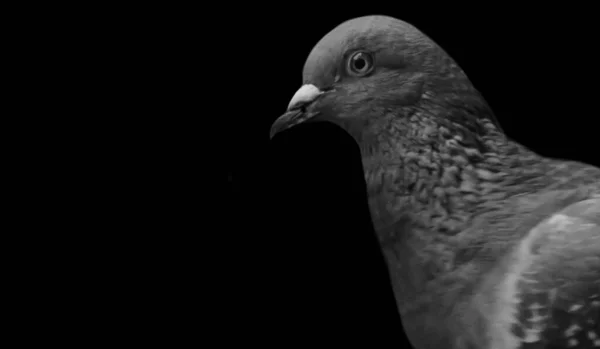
[{"x1": 271, "y1": 16, "x2": 600, "y2": 349}]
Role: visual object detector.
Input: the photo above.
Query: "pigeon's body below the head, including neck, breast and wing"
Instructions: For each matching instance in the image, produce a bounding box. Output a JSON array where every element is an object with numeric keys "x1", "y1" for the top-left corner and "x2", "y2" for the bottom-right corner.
[{"x1": 363, "y1": 115, "x2": 600, "y2": 348}]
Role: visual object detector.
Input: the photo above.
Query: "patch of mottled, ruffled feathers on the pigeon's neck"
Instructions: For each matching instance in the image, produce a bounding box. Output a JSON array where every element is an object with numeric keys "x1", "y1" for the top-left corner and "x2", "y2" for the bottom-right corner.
[{"x1": 363, "y1": 115, "x2": 544, "y2": 234}]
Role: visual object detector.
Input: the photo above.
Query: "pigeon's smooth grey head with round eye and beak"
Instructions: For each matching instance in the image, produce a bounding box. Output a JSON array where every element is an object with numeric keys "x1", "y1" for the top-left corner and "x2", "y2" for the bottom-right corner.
[{"x1": 271, "y1": 16, "x2": 500, "y2": 150}]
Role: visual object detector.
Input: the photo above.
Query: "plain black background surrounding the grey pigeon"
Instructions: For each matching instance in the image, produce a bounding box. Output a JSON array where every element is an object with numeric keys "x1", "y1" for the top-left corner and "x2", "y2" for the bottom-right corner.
[{"x1": 29, "y1": 2, "x2": 600, "y2": 348}]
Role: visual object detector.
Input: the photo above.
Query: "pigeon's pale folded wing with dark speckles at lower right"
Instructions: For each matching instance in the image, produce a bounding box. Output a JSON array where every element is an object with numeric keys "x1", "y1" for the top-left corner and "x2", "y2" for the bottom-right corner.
[{"x1": 491, "y1": 196, "x2": 600, "y2": 349}]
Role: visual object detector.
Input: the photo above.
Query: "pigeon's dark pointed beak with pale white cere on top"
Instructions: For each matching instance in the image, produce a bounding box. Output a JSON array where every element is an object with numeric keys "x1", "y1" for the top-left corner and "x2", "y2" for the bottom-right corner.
[{"x1": 270, "y1": 84, "x2": 323, "y2": 139}]
